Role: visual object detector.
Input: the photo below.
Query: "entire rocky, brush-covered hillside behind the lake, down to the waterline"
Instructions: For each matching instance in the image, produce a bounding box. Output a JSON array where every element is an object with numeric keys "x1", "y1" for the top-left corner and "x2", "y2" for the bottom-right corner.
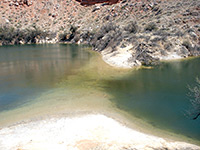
[{"x1": 0, "y1": 0, "x2": 200, "y2": 68}]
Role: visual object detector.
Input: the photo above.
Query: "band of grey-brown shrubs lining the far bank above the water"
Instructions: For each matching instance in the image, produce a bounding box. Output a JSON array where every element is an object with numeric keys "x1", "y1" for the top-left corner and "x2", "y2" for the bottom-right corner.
[{"x1": 0, "y1": 18, "x2": 200, "y2": 65}]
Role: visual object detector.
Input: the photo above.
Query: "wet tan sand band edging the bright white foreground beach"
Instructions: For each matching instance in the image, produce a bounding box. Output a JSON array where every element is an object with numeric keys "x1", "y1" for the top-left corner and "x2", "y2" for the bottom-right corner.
[{"x1": 0, "y1": 107, "x2": 200, "y2": 146}]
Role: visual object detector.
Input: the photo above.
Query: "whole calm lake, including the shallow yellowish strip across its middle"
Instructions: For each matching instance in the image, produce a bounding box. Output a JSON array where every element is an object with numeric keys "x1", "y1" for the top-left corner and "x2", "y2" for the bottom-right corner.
[{"x1": 0, "y1": 44, "x2": 200, "y2": 144}]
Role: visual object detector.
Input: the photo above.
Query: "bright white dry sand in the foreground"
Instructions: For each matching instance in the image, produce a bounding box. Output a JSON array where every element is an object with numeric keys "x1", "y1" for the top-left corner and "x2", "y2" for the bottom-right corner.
[{"x1": 0, "y1": 114, "x2": 200, "y2": 150}]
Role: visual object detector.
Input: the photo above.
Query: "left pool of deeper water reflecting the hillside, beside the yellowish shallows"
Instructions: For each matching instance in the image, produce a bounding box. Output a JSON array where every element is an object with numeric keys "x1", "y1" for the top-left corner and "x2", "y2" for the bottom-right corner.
[{"x1": 0, "y1": 45, "x2": 90, "y2": 111}]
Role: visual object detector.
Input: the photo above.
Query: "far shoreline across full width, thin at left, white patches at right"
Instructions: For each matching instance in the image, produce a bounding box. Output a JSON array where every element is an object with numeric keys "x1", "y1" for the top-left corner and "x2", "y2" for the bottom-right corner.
[{"x1": 0, "y1": 42, "x2": 200, "y2": 70}]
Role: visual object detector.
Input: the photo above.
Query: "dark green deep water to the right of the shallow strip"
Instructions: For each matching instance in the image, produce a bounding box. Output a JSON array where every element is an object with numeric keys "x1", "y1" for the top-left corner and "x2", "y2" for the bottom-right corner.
[{"x1": 101, "y1": 58, "x2": 200, "y2": 140}]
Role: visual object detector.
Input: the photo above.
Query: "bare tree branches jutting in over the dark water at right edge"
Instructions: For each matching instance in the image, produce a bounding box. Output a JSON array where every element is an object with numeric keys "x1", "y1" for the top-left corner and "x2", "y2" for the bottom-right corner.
[{"x1": 189, "y1": 78, "x2": 200, "y2": 120}]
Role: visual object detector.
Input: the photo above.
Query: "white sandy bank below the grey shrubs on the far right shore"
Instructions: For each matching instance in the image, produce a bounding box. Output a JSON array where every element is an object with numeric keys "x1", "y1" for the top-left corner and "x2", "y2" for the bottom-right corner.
[{"x1": 100, "y1": 46, "x2": 200, "y2": 69}]
